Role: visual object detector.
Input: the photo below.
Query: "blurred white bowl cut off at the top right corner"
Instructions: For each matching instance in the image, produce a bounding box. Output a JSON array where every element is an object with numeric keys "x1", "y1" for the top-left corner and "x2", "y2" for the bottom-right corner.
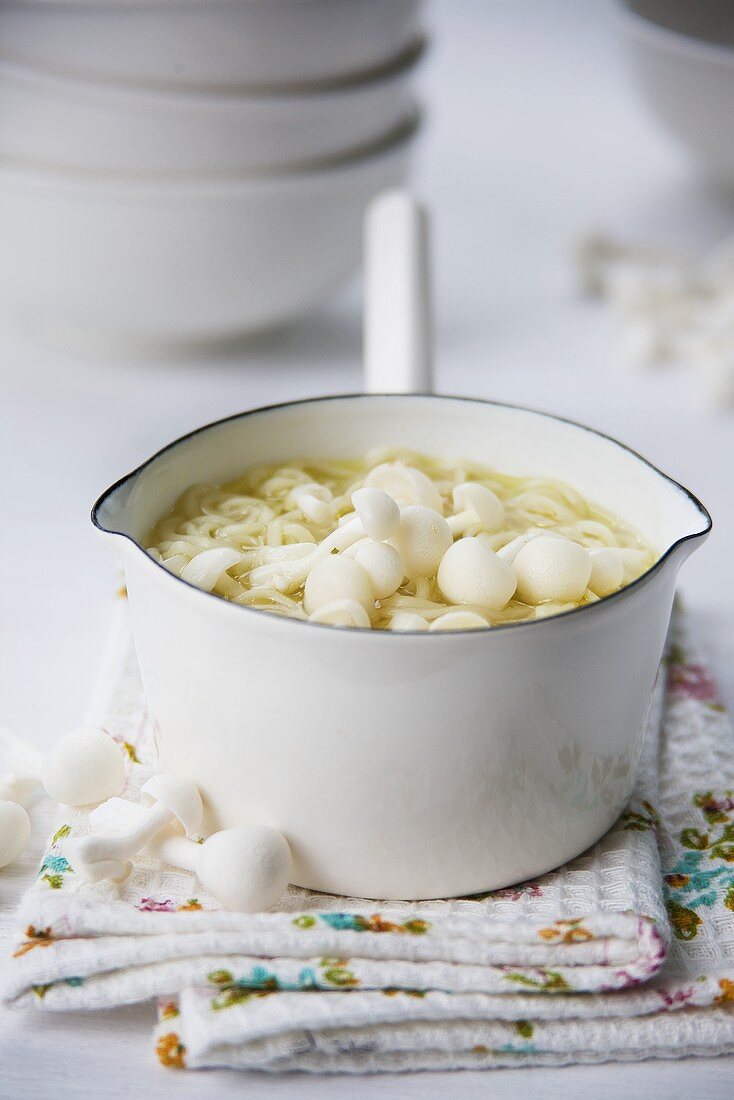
[{"x1": 618, "y1": 0, "x2": 734, "y2": 183}]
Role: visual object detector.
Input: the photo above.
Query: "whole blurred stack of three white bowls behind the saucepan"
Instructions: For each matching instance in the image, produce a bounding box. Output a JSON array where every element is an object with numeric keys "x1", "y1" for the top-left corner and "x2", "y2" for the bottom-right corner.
[{"x1": 0, "y1": 0, "x2": 425, "y2": 343}]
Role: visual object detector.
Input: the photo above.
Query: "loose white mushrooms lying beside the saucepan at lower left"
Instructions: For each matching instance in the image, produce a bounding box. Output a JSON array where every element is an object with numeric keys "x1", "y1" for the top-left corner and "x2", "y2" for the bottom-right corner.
[{"x1": 0, "y1": 727, "x2": 292, "y2": 912}]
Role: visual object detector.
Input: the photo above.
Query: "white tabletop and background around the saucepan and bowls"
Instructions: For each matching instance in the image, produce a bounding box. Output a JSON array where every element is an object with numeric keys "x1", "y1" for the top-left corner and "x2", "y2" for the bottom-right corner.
[{"x1": 0, "y1": 0, "x2": 734, "y2": 1100}]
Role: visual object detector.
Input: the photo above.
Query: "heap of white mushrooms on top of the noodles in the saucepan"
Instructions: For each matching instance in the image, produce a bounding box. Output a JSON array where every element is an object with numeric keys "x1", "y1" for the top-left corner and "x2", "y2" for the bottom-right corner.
[{"x1": 163, "y1": 461, "x2": 649, "y2": 631}]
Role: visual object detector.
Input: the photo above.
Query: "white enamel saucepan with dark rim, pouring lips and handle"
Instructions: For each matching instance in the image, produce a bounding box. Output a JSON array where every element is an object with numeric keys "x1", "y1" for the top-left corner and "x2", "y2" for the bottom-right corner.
[{"x1": 92, "y1": 197, "x2": 711, "y2": 899}]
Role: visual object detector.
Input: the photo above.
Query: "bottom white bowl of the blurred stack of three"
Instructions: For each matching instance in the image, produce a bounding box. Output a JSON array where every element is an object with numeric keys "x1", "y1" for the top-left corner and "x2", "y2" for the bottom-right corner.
[{"x1": 0, "y1": 122, "x2": 415, "y2": 343}]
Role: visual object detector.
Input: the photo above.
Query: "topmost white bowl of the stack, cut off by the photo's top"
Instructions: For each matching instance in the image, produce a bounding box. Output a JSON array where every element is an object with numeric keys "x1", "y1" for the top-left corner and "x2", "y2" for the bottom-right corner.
[{"x1": 0, "y1": 0, "x2": 421, "y2": 88}]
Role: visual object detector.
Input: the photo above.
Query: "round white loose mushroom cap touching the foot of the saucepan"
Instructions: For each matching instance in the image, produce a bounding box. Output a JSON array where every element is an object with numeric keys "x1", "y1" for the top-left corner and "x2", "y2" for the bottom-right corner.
[{"x1": 197, "y1": 825, "x2": 292, "y2": 913}]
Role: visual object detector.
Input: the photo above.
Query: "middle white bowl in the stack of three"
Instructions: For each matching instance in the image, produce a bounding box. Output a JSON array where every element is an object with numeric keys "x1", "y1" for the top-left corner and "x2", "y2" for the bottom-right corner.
[{"x1": 0, "y1": 50, "x2": 420, "y2": 174}]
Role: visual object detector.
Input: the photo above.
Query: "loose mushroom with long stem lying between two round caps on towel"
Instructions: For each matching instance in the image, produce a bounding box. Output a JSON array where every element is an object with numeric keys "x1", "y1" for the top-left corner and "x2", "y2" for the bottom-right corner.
[{"x1": 76, "y1": 774, "x2": 204, "y2": 878}]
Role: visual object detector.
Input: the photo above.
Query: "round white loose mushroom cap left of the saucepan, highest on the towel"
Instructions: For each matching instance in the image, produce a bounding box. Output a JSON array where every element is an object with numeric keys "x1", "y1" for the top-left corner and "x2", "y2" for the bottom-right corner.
[{"x1": 41, "y1": 727, "x2": 124, "y2": 806}]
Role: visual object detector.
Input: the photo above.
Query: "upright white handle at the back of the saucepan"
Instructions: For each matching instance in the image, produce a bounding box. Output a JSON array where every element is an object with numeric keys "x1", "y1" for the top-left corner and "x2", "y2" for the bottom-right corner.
[{"x1": 364, "y1": 190, "x2": 432, "y2": 394}]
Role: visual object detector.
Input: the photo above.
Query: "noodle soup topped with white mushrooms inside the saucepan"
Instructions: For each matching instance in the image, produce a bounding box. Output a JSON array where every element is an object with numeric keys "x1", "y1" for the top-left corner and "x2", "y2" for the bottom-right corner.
[{"x1": 145, "y1": 448, "x2": 656, "y2": 630}]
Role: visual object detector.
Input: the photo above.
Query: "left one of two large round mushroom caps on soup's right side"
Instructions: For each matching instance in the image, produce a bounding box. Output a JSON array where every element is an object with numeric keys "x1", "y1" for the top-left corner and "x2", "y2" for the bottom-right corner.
[{"x1": 437, "y1": 538, "x2": 517, "y2": 611}]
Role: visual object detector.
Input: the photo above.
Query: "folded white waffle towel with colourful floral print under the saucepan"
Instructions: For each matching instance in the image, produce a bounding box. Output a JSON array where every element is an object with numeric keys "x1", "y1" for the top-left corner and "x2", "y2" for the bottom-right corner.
[{"x1": 2, "y1": 601, "x2": 734, "y2": 1073}]
